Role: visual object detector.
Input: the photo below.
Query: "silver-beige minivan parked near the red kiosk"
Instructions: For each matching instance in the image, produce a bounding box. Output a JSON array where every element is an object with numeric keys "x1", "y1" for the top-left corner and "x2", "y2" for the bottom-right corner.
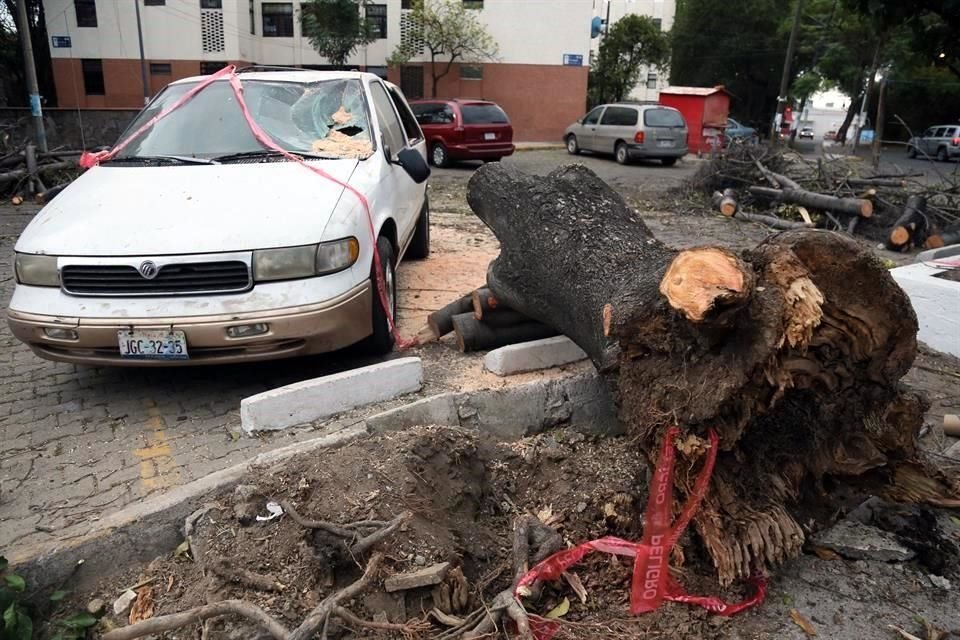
[{"x1": 563, "y1": 103, "x2": 688, "y2": 167}]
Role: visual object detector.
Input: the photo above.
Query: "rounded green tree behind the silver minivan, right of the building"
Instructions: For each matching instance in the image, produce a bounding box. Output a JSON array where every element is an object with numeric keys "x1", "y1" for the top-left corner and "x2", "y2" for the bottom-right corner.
[{"x1": 589, "y1": 14, "x2": 670, "y2": 105}]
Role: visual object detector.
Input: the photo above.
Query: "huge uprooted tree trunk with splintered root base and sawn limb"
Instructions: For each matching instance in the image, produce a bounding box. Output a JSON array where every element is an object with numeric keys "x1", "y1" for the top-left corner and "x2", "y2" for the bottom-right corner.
[{"x1": 468, "y1": 164, "x2": 960, "y2": 583}]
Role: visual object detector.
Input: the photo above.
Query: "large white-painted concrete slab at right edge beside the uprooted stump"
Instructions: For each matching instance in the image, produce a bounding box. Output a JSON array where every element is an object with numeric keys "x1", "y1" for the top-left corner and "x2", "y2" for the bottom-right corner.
[{"x1": 890, "y1": 263, "x2": 960, "y2": 356}]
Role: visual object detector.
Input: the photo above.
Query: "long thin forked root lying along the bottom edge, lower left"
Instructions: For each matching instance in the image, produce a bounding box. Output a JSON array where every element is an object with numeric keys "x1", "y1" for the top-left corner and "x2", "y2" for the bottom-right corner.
[{"x1": 103, "y1": 553, "x2": 390, "y2": 640}]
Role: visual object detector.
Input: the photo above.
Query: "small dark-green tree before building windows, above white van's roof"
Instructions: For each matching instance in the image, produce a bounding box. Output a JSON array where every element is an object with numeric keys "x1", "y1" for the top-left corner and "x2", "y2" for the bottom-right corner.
[{"x1": 300, "y1": 0, "x2": 374, "y2": 67}]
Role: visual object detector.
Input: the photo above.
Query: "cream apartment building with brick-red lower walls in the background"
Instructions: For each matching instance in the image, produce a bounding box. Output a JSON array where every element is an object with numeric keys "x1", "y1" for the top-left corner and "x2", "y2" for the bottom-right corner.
[{"x1": 44, "y1": 0, "x2": 594, "y2": 140}]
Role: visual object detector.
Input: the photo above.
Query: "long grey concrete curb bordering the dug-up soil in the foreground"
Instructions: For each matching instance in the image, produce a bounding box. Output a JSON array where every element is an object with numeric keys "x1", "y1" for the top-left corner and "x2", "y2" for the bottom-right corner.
[{"x1": 15, "y1": 371, "x2": 621, "y2": 592}]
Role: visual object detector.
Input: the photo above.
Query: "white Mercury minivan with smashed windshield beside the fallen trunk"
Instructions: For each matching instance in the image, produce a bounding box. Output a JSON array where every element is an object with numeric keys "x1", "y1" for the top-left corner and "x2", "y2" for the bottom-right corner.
[{"x1": 7, "y1": 70, "x2": 430, "y2": 365}]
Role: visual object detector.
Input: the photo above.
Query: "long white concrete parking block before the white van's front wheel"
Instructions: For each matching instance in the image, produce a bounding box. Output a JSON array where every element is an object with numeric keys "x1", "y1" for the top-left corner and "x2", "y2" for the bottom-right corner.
[{"x1": 240, "y1": 358, "x2": 423, "y2": 433}]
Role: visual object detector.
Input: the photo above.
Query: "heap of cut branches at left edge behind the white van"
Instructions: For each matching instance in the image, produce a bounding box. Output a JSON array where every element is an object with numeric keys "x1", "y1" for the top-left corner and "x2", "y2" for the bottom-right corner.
[{"x1": 0, "y1": 144, "x2": 82, "y2": 204}]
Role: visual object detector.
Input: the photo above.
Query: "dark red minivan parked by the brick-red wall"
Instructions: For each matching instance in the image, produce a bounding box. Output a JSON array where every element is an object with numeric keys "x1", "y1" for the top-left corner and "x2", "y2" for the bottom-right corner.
[{"x1": 410, "y1": 99, "x2": 514, "y2": 167}]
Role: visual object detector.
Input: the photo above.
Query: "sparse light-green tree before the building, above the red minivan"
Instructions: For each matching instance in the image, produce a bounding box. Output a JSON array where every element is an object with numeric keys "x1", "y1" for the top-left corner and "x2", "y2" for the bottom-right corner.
[{"x1": 388, "y1": 0, "x2": 499, "y2": 97}]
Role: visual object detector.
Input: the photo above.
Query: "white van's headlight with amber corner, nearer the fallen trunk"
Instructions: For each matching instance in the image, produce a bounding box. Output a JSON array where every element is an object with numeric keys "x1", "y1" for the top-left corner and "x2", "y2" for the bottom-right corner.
[{"x1": 253, "y1": 238, "x2": 360, "y2": 282}]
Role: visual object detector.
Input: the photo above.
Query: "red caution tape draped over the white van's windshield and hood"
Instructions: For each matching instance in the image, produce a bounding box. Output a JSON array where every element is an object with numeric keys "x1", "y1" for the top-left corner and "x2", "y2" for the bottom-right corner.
[{"x1": 80, "y1": 65, "x2": 419, "y2": 351}]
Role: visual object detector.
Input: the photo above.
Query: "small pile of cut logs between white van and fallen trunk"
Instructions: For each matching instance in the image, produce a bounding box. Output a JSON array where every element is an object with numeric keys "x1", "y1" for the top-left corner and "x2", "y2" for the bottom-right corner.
[{"x1": 420, "y1": 286, "x2": 558, "y2": 353}]
